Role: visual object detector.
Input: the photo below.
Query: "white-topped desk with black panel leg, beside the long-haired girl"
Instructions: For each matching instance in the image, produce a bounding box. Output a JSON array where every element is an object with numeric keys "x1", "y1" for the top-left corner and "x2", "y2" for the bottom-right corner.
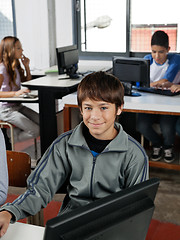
[{"x1": 22, "y1": 74, "x2": 81, "y2": 154}]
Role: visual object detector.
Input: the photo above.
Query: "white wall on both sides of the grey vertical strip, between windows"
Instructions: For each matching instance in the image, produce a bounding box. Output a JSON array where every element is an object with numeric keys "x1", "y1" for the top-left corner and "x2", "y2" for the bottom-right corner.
[{"x1": 15, "y1": 0, "x2": 73, "y2": 70}]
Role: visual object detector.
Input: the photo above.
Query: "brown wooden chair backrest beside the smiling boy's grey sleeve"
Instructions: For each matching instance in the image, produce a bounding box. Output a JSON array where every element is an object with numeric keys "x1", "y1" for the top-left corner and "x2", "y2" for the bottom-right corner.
[{"x1": 6, "y1": 150, "x2": 31, "y2": 187}]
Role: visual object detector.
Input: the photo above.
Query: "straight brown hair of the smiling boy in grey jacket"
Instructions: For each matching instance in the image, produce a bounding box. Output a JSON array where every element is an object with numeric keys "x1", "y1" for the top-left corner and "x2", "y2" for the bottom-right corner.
[{"x1": 77, "y1": 71, "x2": 124, "y2": 109}]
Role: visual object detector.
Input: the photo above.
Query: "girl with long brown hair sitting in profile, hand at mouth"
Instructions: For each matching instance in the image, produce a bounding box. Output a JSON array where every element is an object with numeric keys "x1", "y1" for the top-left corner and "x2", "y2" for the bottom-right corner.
[{"x1": 0, "y1": 36, "x2": 39, "y2": 141}]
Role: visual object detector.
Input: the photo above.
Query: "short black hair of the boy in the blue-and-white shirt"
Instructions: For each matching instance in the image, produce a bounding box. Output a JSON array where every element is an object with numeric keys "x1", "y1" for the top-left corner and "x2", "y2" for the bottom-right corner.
[{"x1": 151, "y1": 31, "x2": 169, "y2": 49}]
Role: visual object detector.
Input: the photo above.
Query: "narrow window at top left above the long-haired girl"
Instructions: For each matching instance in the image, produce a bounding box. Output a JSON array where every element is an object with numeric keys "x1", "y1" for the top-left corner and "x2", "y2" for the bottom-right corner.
[{"x1": 0, "y1": 0, "x2": 15, "y2": 40}]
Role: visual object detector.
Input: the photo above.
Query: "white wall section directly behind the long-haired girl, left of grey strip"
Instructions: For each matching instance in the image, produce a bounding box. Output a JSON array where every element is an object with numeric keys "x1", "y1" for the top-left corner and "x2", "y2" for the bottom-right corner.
[{"x1": 15, "y1": 0, "x2": 49, "y2": 69}]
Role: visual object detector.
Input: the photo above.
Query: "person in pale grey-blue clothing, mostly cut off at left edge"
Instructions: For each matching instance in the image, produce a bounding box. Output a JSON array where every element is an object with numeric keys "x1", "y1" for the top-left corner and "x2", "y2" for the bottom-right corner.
[{"x1": 0, "y1": 129, "x2": 8, "y2": 206}]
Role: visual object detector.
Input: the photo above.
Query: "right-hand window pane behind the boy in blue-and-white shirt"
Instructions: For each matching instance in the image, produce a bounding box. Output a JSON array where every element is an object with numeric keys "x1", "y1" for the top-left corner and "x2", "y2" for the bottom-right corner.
[{"x1": 130, "y1": 0, "x2": 180, "y2": 52}]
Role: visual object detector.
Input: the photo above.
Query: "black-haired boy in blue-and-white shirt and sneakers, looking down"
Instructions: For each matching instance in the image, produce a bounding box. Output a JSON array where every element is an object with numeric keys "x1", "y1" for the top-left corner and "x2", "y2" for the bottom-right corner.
[{"x1": 137, "y1": 31, "x2": 180, "y2": 163}]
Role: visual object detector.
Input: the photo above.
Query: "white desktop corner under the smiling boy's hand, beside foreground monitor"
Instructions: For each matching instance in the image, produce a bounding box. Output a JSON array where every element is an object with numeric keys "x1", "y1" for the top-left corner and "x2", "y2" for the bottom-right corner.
[{"x1": 1, "y1": 222, "x2": 45, "y2": 240}]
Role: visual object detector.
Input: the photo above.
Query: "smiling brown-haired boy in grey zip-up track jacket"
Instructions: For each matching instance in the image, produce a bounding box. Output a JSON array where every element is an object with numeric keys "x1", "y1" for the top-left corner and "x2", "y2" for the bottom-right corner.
[{"x1": 0, "y1": 72, "x2": 149, "y2": 236}]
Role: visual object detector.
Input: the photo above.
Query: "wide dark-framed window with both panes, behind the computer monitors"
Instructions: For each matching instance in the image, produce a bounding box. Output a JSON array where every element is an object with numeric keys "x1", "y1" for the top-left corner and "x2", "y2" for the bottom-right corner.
[{"x1": 77, "y1": 0, "x2": 180, "y2": 56}]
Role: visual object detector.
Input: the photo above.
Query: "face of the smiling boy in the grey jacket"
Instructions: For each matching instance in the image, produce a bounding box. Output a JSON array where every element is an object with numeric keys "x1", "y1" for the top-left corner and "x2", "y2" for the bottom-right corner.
[{"x1": 81, "y1": 98, "x2": 122, "y2": 140}]
